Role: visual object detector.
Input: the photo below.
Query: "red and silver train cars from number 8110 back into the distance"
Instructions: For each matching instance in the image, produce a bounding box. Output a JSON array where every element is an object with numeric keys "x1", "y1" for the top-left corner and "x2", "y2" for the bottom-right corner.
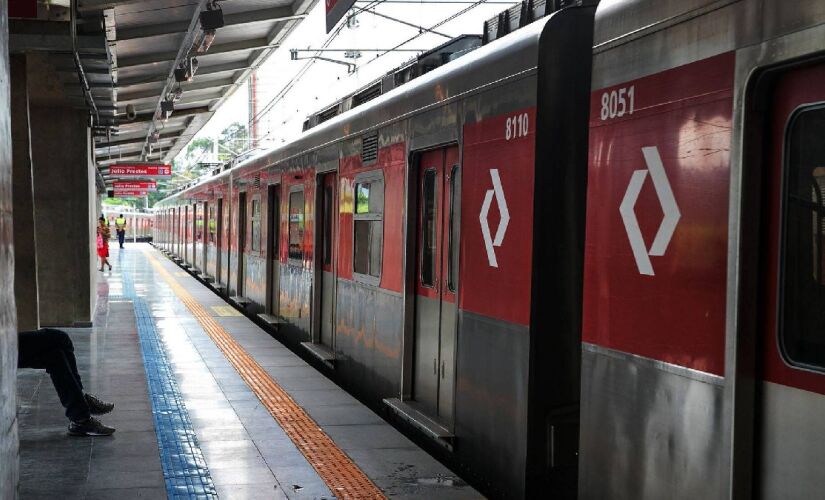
[{"x1": 156, "y1": 2, "x2": 595, "y2": 496}]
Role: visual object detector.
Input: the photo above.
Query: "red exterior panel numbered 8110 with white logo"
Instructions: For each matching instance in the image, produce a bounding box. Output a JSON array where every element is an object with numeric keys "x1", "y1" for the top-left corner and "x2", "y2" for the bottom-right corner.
[{"x1": 459, "y1": 108, "x2": 540, "y2": 326}]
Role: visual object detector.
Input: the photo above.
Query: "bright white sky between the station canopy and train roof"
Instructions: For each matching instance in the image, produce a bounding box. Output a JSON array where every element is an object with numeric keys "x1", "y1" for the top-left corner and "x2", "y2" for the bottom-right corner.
[{"x1": 182, "y1": 0, "x2": 517, "y2": 162}]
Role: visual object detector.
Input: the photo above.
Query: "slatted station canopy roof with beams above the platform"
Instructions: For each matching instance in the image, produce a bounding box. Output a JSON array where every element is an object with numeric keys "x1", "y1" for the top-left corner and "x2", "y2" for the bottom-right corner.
[{"x1": 10, "y1": 0, "x2": 317, "y2": 173}]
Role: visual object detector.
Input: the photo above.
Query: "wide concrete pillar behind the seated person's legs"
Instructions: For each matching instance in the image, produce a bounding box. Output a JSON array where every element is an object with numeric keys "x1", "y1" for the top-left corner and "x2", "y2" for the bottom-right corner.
[{"x1": 29, "y1": 103, "x2": 97, "y2": 326}]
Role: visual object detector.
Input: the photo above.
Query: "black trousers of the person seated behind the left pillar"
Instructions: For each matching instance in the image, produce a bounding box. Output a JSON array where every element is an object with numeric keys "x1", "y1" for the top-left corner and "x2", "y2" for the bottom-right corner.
[{"x1": 17, "y1": 328, "x2": 90, "y2": 422}]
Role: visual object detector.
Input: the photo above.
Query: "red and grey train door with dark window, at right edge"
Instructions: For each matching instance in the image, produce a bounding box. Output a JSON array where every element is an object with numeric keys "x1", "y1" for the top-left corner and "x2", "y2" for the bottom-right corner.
[{"x1": 754, "y1": 65, "x2": 825, "y2": 498}]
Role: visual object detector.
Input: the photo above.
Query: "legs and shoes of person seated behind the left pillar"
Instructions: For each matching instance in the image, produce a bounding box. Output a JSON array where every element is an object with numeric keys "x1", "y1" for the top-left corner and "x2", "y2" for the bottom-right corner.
[{"x1": 17, "y1": 328, "x2": 115, "y2": 436}]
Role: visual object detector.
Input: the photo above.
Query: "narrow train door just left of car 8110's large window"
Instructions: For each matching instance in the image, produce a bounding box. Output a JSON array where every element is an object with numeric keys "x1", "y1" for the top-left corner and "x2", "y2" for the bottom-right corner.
[{"x1": 315, "y1": 172, "x2": 338, "y2": 349}]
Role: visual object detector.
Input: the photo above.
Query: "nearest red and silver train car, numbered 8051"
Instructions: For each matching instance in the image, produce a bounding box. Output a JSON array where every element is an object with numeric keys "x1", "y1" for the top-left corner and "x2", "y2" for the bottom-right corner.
[{"x1": 579, "y1": 0, "x2": 825, "y2": 499}]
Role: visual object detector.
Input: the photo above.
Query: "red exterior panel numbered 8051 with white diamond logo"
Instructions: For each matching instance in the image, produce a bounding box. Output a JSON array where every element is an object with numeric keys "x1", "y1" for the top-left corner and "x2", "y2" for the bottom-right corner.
[{"x1": 582, "y1": 53, "x2": 734, "y2": 375}]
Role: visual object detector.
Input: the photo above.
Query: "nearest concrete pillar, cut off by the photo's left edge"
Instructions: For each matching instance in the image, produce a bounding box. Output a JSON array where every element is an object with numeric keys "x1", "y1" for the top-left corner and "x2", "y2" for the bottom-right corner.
[{"x1": 0, "y1": 0, "x2": 19, "y2": 499}]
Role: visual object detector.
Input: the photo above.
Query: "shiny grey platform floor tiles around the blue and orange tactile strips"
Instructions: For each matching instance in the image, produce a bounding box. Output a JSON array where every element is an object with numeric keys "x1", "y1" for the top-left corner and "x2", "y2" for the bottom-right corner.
[{"x1": 18, "y1": 245, "x2": 479, "y2": 500}]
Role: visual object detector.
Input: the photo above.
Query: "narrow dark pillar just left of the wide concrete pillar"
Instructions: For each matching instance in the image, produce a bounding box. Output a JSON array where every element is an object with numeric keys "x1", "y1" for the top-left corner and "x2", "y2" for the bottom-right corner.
[{"x1": 9, "y1": 54, "x2": 40, "y2": 330}]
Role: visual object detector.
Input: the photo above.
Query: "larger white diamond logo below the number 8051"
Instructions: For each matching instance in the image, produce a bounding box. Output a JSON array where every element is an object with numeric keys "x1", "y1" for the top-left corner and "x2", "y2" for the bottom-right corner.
[{"x1": 619, "y1": 146, "x2": 682, "y2": 276}]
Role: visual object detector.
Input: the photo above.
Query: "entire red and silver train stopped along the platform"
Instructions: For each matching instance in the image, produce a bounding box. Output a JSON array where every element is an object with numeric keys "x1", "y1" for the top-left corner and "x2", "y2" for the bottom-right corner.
[{"x1": 154, "y1": 0, "x2": 825, "y2": 499}]
